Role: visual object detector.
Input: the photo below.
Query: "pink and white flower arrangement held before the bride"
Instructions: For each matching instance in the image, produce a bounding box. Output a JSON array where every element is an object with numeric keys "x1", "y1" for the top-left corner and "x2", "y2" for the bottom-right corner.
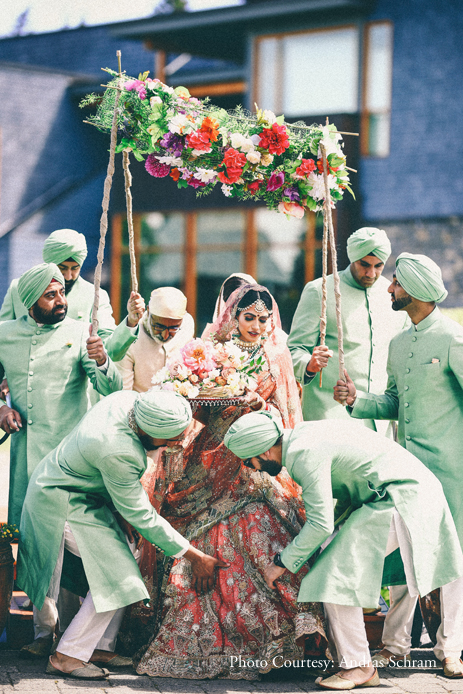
[{"x1": 152, "y1": 338, "x2": 264, "y2": 399}]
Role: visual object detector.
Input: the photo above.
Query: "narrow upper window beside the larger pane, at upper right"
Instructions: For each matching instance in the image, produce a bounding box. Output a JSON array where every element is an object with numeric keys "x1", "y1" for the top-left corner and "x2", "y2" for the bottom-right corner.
[{"x1": 361, "y1": 22, "x2": 393, "y2": 157}]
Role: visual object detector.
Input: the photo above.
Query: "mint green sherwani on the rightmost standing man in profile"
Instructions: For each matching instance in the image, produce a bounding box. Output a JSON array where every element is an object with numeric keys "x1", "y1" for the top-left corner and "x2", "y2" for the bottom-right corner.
[{"x1": 349, "y1": 307, "x2": 463, "y2": 547}]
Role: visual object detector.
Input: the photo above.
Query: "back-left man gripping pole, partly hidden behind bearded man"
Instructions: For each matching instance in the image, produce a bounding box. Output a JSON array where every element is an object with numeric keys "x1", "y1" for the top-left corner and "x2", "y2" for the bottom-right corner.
[{"x1": 0, "y1": 229, "x2": 145, "y2": 370}]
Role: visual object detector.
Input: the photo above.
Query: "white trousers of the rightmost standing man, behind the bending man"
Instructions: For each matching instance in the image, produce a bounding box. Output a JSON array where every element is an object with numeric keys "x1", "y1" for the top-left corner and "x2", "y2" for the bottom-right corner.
[{"x1": 383, "y1": 577, "x2": 463, "y2": 660}]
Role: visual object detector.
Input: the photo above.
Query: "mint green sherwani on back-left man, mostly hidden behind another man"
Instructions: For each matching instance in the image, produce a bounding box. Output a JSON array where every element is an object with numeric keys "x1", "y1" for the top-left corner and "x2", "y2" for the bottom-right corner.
[{"x1": 0, "y1": 275, "x2": 138, "y2": 361}]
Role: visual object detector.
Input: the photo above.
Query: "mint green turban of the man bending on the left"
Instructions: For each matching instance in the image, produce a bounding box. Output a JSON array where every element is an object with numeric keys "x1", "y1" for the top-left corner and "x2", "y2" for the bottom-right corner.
[{"x1": 134, "y1": 390, "x2": 193, "y2": 439}]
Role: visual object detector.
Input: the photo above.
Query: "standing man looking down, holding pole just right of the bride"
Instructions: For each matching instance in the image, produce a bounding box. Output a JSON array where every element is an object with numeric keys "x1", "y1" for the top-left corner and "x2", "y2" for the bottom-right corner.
[{"x1": 288, "y1": 227, "x2": 407, "y2": 434}]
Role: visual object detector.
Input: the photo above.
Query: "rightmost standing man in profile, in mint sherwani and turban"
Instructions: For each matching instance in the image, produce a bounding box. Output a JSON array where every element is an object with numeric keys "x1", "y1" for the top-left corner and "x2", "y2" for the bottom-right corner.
[{"x1": 335, "y1": 253, "x2": 463, "y2": 677}]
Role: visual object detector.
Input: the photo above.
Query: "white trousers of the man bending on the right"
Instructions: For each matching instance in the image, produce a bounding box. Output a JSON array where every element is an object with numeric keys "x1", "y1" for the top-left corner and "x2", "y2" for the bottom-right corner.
[{"x1": 325, "y1": 509, "x2": 418, "y2": 669}]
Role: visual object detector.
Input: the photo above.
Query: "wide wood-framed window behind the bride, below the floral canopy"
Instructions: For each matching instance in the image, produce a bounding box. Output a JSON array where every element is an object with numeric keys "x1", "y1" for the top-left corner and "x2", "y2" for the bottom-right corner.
[{"x1": 111, "y1": 207, "x2": 323, "y2": 334}]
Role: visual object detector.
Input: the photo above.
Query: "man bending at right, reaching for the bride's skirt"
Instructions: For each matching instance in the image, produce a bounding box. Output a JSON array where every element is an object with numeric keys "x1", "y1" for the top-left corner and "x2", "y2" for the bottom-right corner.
[{"x1": 224, "y1": 413, "x2": 463, "y2": 690}]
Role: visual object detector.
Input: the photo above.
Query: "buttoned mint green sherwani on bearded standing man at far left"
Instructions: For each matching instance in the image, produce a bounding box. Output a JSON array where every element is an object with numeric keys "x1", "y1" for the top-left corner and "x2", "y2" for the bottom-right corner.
[{"x1": 0, "y1": 315, "x2": 122, "y2": 526}]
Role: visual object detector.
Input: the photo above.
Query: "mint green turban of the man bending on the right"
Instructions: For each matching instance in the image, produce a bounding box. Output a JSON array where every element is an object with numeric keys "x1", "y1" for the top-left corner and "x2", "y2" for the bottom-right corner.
[{"x1": 224, "y1": 412, "x2": 284, "y2": 460}]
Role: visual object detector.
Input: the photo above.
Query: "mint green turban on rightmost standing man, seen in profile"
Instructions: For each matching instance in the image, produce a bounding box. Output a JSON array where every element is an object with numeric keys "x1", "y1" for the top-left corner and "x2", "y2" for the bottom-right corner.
[{"x1": 395, "y1": 253, "x2": 448, "y2": 304}]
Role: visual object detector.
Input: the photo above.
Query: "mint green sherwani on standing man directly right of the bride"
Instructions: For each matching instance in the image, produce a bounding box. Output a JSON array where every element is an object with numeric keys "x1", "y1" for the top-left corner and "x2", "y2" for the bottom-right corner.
[{"x1": 288, "y1": 266, "x2": 409, "y2": 433}]
